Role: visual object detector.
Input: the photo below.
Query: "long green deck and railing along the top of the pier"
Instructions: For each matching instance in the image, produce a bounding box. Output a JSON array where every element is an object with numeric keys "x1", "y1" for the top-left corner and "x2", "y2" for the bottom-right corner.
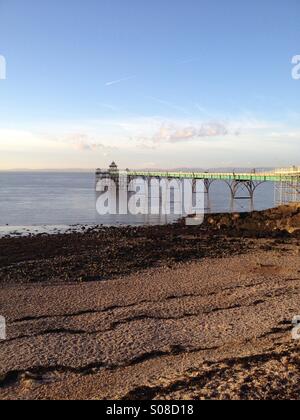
[{"x1": 127, "y1": 171, "x2": 300, "y2": 182}]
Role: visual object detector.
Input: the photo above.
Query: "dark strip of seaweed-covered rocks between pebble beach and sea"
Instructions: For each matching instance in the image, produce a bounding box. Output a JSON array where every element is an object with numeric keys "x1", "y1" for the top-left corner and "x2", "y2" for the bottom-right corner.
[{"x1": 0, "y1": 205, "x2": 300, "y2": 285}]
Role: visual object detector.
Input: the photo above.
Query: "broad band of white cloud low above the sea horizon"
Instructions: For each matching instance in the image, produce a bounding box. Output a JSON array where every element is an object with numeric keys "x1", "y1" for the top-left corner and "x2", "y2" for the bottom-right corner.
[{"x1": 0, "y1": 115, "x2": 300, "y2": 168}]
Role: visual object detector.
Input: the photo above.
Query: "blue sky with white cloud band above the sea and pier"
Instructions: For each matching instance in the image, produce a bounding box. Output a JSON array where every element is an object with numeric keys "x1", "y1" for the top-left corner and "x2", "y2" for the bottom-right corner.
[{"x1": 0, "y1": 0, "x2": 300, "y2": 170}]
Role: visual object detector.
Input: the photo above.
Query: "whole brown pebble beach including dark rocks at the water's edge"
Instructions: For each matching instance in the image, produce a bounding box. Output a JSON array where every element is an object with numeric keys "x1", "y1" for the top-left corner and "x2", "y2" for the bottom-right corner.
[{"x1": 0, "y1": 207, "x2": 300, "y2": 400}]
